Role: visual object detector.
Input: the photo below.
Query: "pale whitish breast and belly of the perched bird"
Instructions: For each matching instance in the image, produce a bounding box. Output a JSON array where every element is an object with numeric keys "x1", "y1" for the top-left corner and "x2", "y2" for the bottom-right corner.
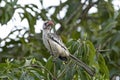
[{"x1": 43, "y1": 31, "x2": 69, "y2": 57}]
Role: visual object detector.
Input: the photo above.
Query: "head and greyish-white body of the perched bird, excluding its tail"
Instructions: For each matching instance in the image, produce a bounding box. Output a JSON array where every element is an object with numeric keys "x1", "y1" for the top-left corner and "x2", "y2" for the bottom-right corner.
[{"x1": 42, "y1": 21, "x2": 69, "y2": 60}]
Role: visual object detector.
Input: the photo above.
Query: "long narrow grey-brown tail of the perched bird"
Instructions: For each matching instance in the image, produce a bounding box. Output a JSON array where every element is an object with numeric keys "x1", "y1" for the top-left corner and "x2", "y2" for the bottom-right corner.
[{"x1": 70, "y1": 54, "x2": 95, "y2": 76}]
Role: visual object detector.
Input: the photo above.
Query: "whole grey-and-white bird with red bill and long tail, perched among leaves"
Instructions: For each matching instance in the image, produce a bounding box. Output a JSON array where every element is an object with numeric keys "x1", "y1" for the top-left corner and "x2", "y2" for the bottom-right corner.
[{"x1": 42, "y1": 20, "x2": 95, "y2": 76}]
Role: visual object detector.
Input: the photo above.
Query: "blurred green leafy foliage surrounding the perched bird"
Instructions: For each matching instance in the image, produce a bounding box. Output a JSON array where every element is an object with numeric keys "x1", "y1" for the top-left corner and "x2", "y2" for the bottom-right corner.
[{"x1": 0, "y1": 0, "x2": 120, "y2": 80}]
